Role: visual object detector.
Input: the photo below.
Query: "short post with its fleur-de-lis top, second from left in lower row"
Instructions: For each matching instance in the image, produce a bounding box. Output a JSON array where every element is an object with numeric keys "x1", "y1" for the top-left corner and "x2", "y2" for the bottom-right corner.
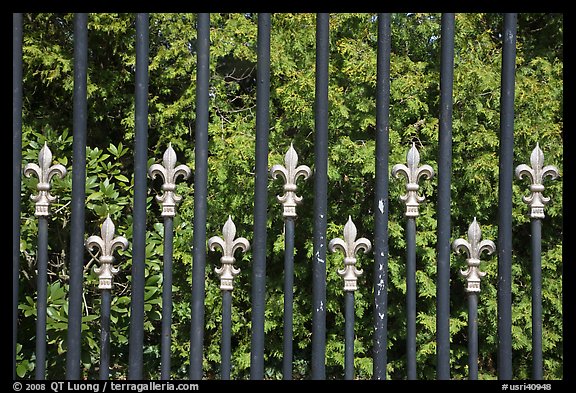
[{"x1": 208, "y1": 216, "x2": 250, "y2": 380}]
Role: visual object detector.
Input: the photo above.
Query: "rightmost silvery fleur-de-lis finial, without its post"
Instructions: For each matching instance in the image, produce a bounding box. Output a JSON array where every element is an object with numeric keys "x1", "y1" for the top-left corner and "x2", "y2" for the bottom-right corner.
[{"x1": 516, "y1": 143, "x2": 559, "y2": 218}]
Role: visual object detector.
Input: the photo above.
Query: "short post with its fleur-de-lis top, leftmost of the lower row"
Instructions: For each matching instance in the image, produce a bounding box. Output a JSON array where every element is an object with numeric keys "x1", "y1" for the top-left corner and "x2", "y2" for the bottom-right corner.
[{"x1": 86, "y1": 216, "x2": 128, "y2": 380}]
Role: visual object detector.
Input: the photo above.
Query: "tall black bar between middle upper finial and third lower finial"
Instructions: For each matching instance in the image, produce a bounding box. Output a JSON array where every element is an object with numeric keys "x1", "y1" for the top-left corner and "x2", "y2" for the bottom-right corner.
[{"x1": 312, "y1": 13, "x2": 330, "y2": 379}]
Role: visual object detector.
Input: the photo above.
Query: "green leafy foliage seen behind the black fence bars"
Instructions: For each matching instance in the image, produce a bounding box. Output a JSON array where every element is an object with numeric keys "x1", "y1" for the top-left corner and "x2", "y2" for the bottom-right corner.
[{"x1": 17, "y1": 13, "x2": 563, "y2": 379}]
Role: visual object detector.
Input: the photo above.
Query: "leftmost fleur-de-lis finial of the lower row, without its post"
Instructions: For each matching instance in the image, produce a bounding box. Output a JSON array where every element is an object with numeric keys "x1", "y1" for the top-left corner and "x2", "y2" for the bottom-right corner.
[{"x1": 86, "y1": 215, "x2": 128, "y2": 289}]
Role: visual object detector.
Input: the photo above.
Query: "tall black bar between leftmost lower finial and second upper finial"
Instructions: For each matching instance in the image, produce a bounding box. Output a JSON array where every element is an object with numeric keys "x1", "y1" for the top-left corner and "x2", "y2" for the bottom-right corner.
[{"x1": 128, "y1": 13, "x2": 149, "y2": 379}]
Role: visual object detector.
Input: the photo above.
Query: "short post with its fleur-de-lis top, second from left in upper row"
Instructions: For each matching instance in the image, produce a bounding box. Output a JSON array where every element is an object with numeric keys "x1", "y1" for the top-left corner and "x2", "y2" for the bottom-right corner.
[{"x1": 148, "y1": 143, "x2": 191, "y2": 380}]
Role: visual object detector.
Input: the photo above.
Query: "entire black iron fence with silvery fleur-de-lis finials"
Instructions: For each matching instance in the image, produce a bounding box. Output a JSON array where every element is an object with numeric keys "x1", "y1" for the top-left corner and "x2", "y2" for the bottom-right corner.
[{"x1": 12, "y1": 13, "x2": 558, "y2": 379}]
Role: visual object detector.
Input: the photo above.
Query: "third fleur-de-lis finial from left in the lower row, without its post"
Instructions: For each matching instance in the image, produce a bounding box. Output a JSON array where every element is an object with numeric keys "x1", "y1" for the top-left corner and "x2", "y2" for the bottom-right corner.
[{"x1": 328, "y1": 216, "x2": 372, "y2": 291}]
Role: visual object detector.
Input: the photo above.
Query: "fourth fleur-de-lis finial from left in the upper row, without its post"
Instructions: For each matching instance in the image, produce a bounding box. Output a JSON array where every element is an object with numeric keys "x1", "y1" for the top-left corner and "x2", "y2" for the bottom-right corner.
[{"x1": 392, "y1": 142, "x2": 434, "y2": 217}]
